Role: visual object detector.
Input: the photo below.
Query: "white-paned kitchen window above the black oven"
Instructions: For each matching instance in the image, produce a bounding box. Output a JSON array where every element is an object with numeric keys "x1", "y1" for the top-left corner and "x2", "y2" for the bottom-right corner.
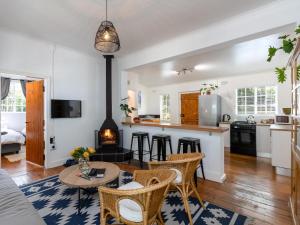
[{"x1": 236, "y1": 86, "x2": 277, "y2": 115}]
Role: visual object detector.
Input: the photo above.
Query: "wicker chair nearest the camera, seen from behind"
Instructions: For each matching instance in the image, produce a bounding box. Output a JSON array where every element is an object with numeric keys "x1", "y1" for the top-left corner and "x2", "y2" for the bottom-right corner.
[{"x1": 99, "y1": 169, "x2": 176, "y2": 225}]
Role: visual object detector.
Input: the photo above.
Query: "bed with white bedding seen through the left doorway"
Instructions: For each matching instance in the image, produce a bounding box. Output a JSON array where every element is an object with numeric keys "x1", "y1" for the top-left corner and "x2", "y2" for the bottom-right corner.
[{"x1": 1, "y1": 128, "x2": 26, "y2": 154}]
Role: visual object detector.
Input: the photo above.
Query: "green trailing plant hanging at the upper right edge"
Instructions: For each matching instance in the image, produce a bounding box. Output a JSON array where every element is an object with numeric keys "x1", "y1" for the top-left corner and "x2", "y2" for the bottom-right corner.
[{"x1": 267, "y1": 25, "x2": 300, "y2": 83}]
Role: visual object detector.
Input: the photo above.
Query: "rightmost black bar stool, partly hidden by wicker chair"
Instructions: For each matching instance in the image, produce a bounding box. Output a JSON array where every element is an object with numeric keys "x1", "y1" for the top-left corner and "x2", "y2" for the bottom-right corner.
[{"x1": 177, "y1": 137, "x2": 205, "y2": 185}]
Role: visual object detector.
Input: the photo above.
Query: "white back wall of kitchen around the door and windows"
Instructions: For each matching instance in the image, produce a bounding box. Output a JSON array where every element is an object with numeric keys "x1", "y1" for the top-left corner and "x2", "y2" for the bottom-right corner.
[{"x1": 131, "y1": 71, "x2": 291, "y2": 123}]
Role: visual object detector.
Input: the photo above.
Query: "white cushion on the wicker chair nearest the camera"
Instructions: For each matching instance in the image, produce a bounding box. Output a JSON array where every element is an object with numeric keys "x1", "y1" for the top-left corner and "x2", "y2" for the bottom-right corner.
[{"x1": 118, "y1": 181, "x2": 144, "y2": 223}]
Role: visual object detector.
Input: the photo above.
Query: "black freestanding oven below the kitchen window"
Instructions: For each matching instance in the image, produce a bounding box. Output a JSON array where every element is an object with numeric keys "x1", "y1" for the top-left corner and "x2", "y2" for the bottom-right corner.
[{"x1": 230, "y1": 121, "x2": 256, "y2": 156}]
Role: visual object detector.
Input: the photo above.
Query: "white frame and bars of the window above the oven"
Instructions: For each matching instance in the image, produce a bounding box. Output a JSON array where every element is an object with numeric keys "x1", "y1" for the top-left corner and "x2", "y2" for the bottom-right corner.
[{"x1": 235, "y1": 85, "x2": 278, "y2": 116}]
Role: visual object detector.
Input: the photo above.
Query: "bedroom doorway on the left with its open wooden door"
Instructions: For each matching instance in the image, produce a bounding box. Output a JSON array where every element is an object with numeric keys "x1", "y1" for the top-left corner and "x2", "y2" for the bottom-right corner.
[{"x1": 1, "y1": 74, "x2": 45, "y2": 173}]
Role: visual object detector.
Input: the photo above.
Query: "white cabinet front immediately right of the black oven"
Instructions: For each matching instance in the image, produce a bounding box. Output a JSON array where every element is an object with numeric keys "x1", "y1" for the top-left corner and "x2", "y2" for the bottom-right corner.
[{"x1": 256, "y1": 125, "x2": 271, "y2": 158}]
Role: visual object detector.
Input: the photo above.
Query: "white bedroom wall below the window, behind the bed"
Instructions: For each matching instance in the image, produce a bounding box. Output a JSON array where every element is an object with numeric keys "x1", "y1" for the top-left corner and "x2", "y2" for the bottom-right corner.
[{"x1": 1, "y1": 112, "x2": 26, "y2": 131}]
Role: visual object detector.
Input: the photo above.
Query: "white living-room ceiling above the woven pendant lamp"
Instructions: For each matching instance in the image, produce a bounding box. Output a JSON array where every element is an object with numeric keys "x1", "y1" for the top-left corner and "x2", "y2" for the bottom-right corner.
[{"x1": 0, "y1": 0, "x2": 276, "y2": 55}]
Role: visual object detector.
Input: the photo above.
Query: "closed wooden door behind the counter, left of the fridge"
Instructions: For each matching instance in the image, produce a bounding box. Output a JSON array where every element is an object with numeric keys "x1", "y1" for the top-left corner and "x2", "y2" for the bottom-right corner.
[{"x1": 180, "y1": 93, "x2": 199, "y2": 125}]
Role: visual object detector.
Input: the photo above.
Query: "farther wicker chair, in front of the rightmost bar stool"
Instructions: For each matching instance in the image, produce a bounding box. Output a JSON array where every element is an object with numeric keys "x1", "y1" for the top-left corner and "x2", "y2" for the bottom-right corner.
[{"x1": 149, "y1": 152, "x2": 205, "y2": 224}]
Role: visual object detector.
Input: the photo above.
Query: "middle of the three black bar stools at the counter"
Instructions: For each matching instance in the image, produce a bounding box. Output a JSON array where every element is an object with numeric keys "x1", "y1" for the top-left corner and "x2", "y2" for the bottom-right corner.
[{"x1": 150, "y1": 134, "x2": 173, "y2": 161}]
